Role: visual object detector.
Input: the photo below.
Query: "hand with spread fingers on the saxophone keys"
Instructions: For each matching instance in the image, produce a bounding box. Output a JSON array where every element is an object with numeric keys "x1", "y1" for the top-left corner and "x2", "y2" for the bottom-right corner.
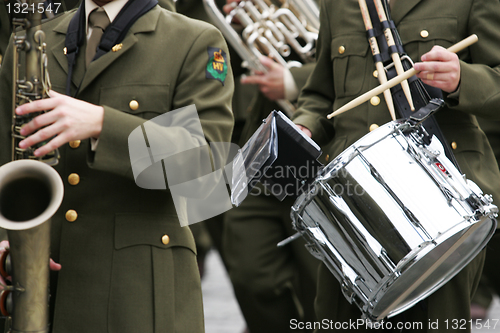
[{"x1": 16, "y1": 90, "x2": 104, "y2": 156}]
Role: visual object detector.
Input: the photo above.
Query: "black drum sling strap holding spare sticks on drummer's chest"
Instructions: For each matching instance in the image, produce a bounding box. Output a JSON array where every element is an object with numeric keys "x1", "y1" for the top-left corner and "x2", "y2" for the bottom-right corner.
[{"x1": 366, "y1": 0, "x2": 460, "y2": 170}]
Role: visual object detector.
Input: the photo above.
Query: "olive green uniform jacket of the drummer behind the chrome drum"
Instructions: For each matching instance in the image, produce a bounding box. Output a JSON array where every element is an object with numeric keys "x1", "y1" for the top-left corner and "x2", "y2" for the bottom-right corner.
[{"x1": 294, "y1": 0, "x2": 500, "y2": 329}]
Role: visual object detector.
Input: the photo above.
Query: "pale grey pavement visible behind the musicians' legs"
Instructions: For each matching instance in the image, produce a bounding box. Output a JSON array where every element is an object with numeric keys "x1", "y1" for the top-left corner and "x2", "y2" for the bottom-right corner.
[{"x1": 202, "y1": 251, "x2": 500, "y2": 333}]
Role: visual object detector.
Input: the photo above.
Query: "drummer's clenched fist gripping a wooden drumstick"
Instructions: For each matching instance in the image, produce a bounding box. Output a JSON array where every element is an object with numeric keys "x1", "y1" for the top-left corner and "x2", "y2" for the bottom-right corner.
[{"x1": 414, "y1": 46, "x2": 460, "y2": 93}]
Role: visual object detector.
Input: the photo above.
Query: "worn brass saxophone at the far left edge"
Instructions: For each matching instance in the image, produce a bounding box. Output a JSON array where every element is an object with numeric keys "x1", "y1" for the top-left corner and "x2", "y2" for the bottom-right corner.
[{"x1": 0, "y1": 0, "x2": 63, "y2": 332}]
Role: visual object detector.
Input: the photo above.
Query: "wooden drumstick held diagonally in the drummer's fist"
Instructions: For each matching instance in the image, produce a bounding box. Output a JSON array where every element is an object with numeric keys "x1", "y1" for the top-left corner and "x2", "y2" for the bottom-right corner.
[{"x1": 327, "y1": 35, "x2": 478, "y2": 119}]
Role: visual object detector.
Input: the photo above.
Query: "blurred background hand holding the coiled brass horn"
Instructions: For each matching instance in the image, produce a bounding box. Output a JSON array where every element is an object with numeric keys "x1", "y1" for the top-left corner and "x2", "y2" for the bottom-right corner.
[{"x1": 241, "y1": 57, "x2": 285, "y2": 101}]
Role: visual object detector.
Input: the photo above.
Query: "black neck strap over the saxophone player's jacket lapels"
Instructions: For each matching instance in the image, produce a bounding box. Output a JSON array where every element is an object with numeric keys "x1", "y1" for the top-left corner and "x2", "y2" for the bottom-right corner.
[{"x1": 65, "y1": 0, "x2": 158, "y2": 96}]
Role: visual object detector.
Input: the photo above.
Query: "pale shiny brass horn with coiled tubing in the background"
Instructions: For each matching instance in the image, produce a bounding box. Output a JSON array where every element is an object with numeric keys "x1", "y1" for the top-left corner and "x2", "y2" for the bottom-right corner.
[{"x1": 203, "y1": 0, "x2": 319, "y2": 116}]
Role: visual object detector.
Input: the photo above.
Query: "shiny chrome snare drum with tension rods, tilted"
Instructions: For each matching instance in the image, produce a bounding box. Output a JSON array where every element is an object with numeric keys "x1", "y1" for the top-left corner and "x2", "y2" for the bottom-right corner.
[{"x1": 291, "y1": 121, "x2": 498, "y2": 321}]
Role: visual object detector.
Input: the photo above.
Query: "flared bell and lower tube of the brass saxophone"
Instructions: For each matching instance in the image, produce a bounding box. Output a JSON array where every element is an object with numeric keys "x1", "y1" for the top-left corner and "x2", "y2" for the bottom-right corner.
[{"x1": 0, "y1": 160, "x2": 64, "y2": 332}]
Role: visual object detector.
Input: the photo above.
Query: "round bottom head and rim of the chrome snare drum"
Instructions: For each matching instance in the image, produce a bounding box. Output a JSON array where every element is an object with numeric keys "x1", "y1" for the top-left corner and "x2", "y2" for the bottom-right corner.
[{"x1": 370, "y1": 217, "x2": 496, "y2": 320}]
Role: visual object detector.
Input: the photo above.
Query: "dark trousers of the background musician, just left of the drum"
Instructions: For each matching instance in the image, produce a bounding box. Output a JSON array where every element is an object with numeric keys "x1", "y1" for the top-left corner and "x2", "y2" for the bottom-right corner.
[{"x1": 224, "y1": 188, "x2": 319, "y2": 333}]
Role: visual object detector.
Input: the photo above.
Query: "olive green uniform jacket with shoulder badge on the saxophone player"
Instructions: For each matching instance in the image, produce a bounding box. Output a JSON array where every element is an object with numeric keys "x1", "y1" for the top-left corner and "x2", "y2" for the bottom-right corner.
[{"x1": 0, "y1": 6, "x2": 233, "y2": 333}]
